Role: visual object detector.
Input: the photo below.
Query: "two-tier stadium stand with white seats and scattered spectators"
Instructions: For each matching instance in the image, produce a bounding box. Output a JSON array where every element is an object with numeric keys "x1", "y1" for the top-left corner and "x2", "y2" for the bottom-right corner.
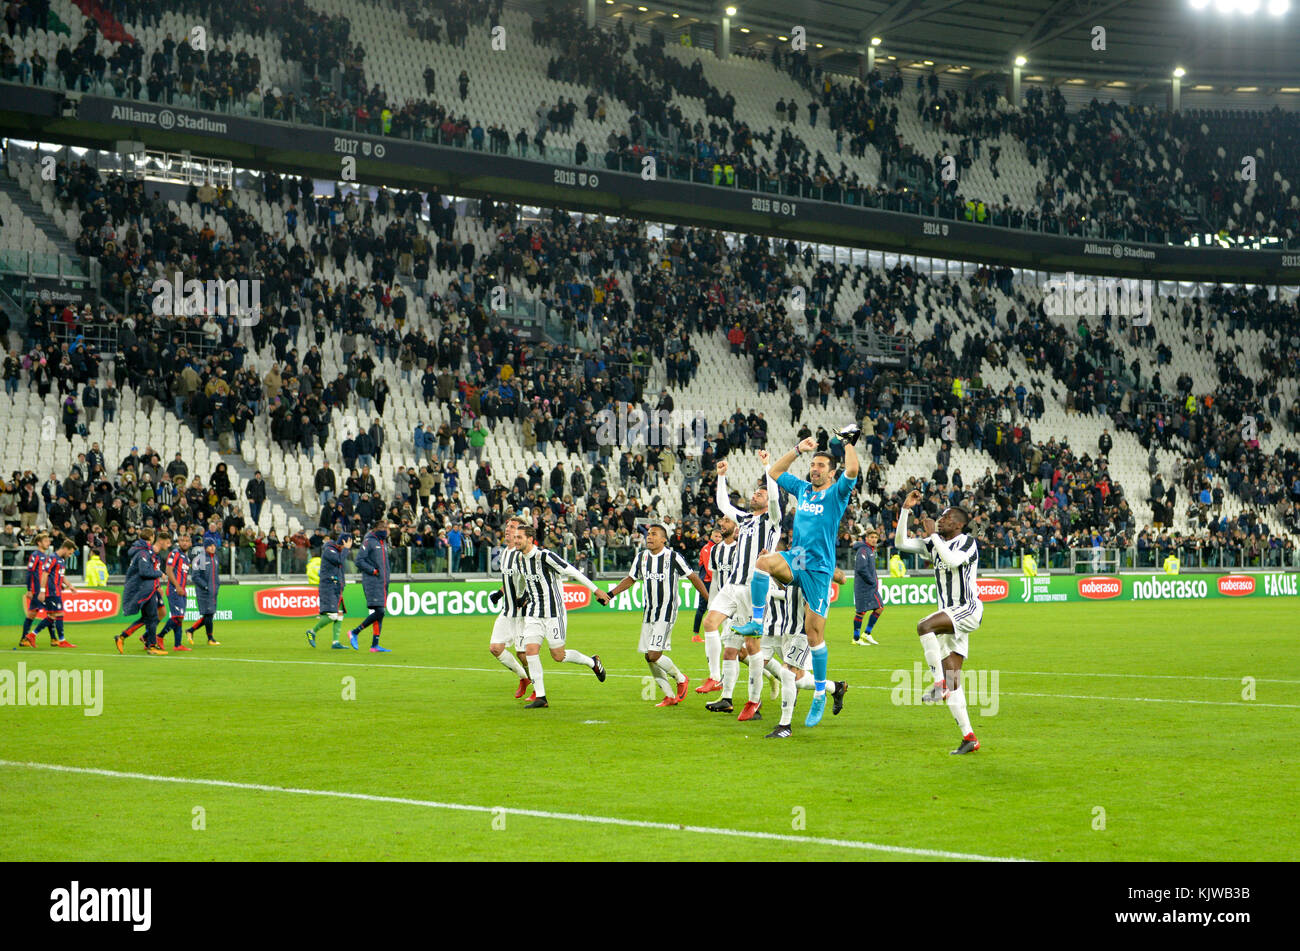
[{"x1": 0, "y1": 0, "x2": 1300, "y2": 579}]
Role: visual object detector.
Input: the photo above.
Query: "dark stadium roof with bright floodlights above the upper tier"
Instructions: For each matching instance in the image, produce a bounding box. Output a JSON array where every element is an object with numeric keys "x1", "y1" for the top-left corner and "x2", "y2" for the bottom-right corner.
[{"x1": 598, "y1": 0, "x2": 1300, "y2": 91}]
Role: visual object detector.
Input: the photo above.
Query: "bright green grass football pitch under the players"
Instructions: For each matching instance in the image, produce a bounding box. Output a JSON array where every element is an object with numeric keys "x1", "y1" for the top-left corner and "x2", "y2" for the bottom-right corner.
[{"x1": 0, "y1": 600, "x2": 1300, "y2": 860}]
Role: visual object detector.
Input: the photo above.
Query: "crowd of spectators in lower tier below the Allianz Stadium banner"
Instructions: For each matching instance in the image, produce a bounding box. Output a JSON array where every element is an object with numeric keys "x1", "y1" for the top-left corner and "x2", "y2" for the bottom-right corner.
[{"x1": 0, "y1": 151, "x2": 1300, "y2": 570}]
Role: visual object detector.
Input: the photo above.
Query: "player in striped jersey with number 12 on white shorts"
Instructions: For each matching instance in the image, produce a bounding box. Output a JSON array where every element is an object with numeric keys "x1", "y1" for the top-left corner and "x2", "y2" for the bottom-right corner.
[{"x1": 610, "y1": 522, "x2": 709, "y2": 707}]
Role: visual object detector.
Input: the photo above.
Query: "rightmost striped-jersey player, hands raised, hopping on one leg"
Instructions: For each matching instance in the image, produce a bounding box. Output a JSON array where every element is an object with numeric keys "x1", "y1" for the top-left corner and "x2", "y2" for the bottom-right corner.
[{"x1": 894, "y1": 490, "x2": 984, "y2": 754}]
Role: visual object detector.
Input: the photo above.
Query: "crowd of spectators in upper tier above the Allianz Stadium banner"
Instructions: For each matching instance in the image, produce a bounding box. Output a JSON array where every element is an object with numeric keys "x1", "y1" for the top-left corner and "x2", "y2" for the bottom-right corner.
[{"x1": 0, "y1": 0, "x2": 1300, "y2": 242}]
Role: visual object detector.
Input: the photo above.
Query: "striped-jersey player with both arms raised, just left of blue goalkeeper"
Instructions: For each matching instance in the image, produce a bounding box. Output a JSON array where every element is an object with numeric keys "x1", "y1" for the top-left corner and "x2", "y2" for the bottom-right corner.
[{"x1": 705, "y1": 451, "x2": 781, "y2": 720}]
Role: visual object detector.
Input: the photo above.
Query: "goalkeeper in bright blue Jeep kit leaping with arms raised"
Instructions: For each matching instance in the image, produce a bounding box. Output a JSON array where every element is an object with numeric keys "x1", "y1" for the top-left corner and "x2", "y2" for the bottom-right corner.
[{"x1": 735, "y1": 425, "x2": 862, "y2": 726}]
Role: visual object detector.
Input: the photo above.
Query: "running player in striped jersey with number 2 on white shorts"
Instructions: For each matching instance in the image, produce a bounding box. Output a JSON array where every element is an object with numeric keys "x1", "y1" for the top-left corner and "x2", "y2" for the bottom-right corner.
[{"x1": 516, "y1": 521, "x2": 610, "y2": 708}]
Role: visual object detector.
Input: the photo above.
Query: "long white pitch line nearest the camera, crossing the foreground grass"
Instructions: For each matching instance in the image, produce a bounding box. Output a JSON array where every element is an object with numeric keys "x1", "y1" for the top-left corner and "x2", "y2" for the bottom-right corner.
[{"x1": 0, "y1": 760, "x2": 1030, "y2": 861}]
